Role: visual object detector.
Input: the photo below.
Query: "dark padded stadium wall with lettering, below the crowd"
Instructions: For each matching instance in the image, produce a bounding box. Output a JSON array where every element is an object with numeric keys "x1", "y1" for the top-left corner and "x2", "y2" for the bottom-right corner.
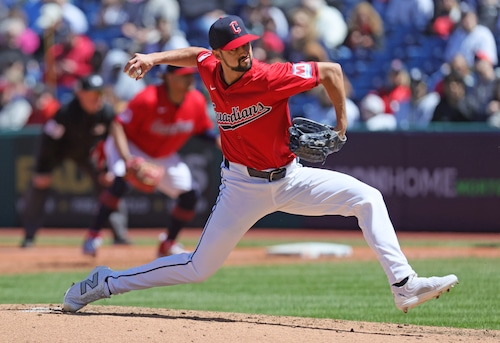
[{"x1": 0, "y1": 126, "x2": 500, "y2": 232}]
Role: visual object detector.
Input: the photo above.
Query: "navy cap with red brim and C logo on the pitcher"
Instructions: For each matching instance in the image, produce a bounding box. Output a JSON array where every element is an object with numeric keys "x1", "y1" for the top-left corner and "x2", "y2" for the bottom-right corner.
[{"x1": 208, "y1": 15, "x2": 260, "y2": 50}]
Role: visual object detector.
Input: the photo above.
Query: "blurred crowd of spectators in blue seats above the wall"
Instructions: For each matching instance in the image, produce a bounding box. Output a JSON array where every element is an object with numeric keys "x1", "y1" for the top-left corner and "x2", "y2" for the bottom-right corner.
[{"x1": 0, "y1": 0, "x2": 500, "y2": 130}]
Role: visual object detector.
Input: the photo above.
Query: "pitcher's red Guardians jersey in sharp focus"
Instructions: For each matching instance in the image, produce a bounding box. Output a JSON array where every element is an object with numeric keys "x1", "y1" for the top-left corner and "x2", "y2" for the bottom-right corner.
[{"x1": 198, "y1": 51, "x2": 319, "y2": 170}]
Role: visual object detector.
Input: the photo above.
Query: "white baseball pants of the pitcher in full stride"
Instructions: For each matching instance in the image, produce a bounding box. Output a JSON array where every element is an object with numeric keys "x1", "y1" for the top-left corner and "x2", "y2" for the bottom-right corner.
[{"x1": 108, "y1": 161, "x2": 414, "y2": 294}]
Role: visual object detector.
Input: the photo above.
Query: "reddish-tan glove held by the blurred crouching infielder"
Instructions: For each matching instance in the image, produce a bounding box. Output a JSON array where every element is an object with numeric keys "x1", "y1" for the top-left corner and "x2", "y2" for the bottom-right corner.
[{"x1": 125, "y1": 157, "x2": 165, "y2": 193}]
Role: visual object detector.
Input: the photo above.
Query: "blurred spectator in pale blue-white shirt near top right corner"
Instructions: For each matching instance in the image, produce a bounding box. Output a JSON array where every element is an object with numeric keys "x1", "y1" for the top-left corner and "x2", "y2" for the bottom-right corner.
[{"x1": 444, "y1": 3, "x2": 498, "y2": 67}]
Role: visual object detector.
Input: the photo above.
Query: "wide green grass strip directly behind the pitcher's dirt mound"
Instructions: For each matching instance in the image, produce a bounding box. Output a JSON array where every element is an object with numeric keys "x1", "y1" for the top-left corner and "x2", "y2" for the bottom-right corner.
[{"x1": 0, "y1": 258, "x2": 500, "y2": 330}]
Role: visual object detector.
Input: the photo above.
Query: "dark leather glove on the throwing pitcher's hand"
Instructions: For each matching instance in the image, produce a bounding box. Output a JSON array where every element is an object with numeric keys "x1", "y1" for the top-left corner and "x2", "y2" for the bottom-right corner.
[{"x1": 288, "y1": 117, "x2": 347, "y2": 164}]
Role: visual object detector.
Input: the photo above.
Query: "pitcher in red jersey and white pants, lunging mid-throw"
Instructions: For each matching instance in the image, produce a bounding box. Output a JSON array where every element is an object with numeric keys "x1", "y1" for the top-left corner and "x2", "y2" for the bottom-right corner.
[{"x1": 63, "y1": 16, "x2": 458, "y2": 318}]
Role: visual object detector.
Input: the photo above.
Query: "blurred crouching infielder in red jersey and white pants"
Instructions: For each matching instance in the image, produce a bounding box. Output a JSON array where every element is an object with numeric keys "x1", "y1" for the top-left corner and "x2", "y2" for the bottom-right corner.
[{"x1": 83, "y1": 66, "x2": 217, "y2": 256}]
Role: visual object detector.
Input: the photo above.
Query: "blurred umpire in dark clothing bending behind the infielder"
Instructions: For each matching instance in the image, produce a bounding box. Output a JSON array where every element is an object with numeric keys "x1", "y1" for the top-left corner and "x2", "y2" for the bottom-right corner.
[{"x1": 21, "y1": 74, "x2": 130, "y2": 248}]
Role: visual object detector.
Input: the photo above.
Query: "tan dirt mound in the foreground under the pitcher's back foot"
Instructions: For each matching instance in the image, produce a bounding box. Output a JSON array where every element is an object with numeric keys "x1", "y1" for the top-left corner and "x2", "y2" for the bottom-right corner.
[{"x1": 0, "y1": 305, "x2": 500, "y2": 343}]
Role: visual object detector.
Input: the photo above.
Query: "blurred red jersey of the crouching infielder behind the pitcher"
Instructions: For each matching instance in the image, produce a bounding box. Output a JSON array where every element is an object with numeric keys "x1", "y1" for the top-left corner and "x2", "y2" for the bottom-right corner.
[{"x1": 117, "y1": 84, "x2": 213, "y2": 158}]
